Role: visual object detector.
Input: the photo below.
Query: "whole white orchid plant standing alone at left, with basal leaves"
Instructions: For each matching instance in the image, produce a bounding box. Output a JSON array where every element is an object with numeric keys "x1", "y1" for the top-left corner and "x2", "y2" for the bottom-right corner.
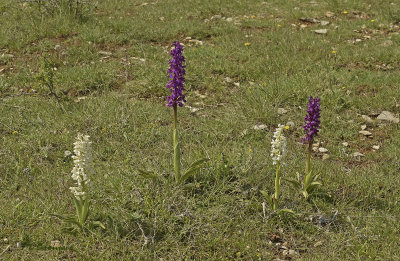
[{"x1": 54, "y1": 133, "x2": 103, "y2": 229}]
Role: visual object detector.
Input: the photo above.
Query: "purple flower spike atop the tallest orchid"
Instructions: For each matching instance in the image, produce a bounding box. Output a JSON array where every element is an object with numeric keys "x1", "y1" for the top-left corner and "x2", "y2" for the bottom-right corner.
[{"x1": 165, "y1": 41, "x2": 186, "y2": 107}]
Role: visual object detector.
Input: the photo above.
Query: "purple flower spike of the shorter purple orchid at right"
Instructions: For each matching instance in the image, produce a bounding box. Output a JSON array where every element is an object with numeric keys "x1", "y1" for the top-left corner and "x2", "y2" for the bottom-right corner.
[{"x1": 302, "y1": 96, "x2": 321, "y2": 143}]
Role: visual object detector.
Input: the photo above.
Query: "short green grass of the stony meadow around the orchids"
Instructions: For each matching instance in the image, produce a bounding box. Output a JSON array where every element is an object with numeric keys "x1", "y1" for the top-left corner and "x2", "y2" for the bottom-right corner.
[{"x1": 0, "y1": 0, "x2": 400, "y2": 260}]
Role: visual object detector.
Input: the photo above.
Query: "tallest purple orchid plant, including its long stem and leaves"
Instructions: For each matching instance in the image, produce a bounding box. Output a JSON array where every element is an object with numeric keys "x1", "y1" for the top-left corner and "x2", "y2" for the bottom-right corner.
[{"x1": 138, "y1": 41, "x2": 207, "y2": 184}]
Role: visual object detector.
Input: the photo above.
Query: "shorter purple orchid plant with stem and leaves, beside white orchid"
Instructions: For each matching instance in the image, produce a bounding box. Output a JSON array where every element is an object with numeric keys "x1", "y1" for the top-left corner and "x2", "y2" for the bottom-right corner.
[{"x1": 288, "y1": 96, "x2": 321, "y2": 199}]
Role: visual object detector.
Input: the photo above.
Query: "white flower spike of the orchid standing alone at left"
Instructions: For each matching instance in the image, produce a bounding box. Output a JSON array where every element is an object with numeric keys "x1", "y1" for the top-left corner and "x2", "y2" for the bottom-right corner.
[{"x1": 69, "y1": 133, "x2": 93, "y2": 199}]
